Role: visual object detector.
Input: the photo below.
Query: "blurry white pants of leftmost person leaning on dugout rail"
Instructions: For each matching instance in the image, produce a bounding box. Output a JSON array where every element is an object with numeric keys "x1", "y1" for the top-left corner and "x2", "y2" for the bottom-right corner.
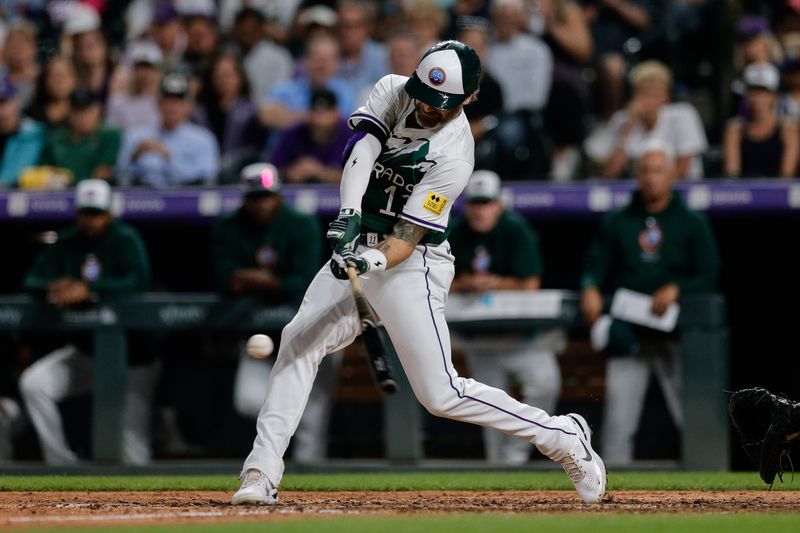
[{"x1": 19, "y1": 344, "x2": 160, "y2": 465}]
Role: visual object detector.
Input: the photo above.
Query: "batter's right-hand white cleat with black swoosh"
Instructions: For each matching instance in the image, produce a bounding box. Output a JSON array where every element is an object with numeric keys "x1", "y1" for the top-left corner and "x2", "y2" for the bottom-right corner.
[{"x1": 561, "y1": 413, "x2": 606, "y2": 503}]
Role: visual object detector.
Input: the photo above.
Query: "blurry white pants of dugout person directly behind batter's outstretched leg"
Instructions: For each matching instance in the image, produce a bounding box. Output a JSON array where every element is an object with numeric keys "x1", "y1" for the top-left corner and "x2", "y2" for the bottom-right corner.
[{"x1": 459, "y1": 329, "x2": 566, "y2": 465}]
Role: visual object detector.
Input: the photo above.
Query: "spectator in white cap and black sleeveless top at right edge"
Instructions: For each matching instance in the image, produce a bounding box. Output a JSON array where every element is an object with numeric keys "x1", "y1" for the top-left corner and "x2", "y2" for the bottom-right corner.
[{"x1": 723, "y1": 62, "x2": 800, "y2": 178}]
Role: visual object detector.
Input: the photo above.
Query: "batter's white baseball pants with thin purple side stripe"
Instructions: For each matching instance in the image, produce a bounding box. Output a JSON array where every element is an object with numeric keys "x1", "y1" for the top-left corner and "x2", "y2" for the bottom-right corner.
[{"x1": 242, "y1": 243, "x2": 577, "y2": 486}]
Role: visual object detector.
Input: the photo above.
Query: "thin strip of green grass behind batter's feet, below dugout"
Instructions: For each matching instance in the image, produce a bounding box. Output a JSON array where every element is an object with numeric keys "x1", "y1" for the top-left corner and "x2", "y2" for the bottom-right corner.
[{"x1": 0, "y1": 471, "x2": 800, "y2": 491}]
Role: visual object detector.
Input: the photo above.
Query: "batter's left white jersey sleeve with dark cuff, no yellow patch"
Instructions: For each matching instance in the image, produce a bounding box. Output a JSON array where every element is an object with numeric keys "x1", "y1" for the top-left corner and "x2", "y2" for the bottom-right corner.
[{"x1": 347, "y1": 74, "x2": 406, "y2": 144}]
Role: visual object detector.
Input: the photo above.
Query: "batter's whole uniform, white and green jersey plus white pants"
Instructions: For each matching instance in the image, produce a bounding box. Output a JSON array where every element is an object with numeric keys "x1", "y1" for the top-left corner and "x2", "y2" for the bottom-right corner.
[{"x1": 242, "y1": 75, "x2": 577, "y2": 487}]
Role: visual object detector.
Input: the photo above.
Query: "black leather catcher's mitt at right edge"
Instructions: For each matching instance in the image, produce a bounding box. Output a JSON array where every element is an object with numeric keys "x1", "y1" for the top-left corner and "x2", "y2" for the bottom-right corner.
[{"x1": 728, "y1": 387, "x2": 800, "y2": 487}]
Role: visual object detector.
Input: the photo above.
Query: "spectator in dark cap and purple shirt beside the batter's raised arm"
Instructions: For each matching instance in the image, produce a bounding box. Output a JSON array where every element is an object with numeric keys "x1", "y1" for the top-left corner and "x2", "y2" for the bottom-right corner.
[{"x1": 272, "y1": 89, "x2": 350, "y2": 183}]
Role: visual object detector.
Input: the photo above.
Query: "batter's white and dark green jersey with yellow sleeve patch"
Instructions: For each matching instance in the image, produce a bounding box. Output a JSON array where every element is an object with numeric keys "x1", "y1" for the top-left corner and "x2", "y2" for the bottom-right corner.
[{"x1": 348, "y1": 75, "x2": 474, "y2": 244}]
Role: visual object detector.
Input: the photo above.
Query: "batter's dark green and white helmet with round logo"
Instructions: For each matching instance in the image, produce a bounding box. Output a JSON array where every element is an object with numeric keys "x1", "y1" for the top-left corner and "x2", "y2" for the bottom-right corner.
[{"x1": 405, "y1": 41, "x2": 481, "y2": 109}]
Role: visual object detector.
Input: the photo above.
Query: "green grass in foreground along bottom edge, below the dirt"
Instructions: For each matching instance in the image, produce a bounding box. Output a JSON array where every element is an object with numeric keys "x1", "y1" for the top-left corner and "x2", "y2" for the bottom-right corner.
[{"x1": 20, "y1": 514, "x2": 800, "y2": 533}]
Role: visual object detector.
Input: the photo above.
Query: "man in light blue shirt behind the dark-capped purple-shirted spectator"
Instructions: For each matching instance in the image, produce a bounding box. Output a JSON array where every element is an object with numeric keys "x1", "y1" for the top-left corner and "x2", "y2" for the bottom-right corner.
[{"x1": 259, "y1": 34, "x2": 355, "y2": 129}]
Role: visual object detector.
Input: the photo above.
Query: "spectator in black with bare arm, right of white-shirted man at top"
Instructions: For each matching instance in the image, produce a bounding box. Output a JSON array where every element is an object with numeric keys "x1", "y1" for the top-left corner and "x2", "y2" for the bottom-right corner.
[{"x1": 537, "y1": 0, "x2": 593, "y2": 181}]
